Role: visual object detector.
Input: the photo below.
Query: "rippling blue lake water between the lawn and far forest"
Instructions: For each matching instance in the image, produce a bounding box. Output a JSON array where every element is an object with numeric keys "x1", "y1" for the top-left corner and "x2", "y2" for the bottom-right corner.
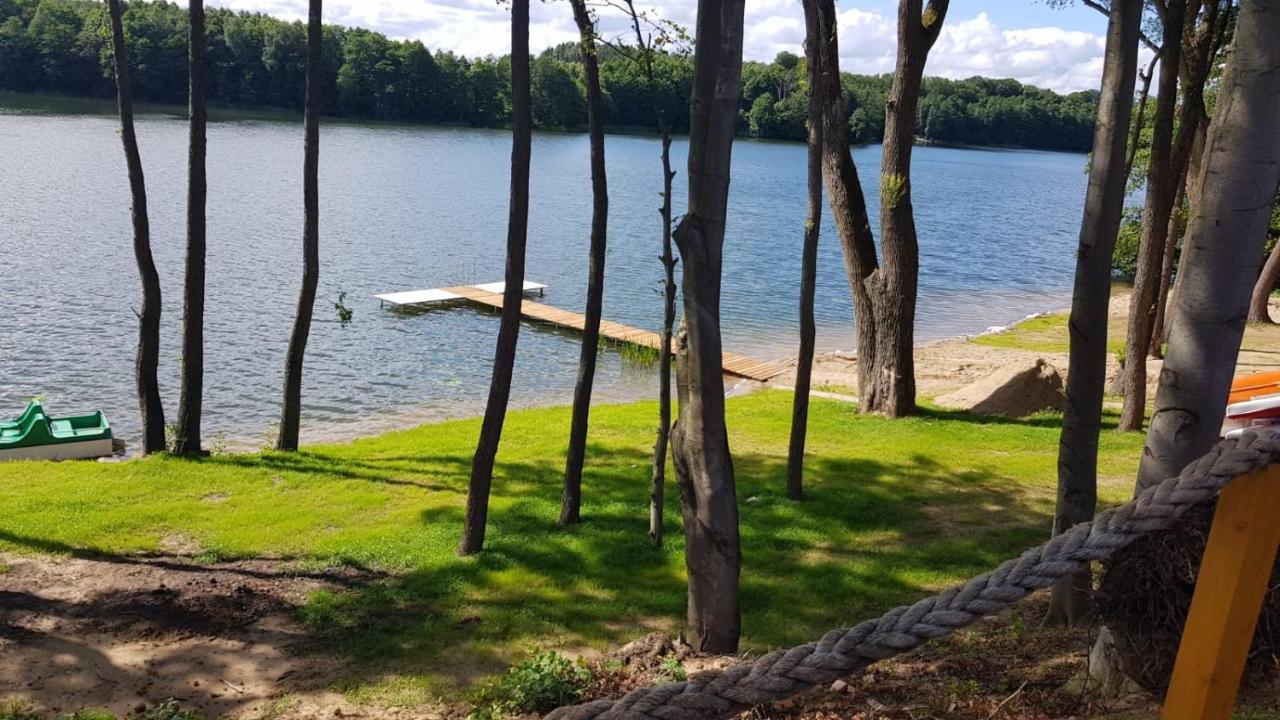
[{"x1": 0, "y1": 103, "x2": 1085, "y2": 447}]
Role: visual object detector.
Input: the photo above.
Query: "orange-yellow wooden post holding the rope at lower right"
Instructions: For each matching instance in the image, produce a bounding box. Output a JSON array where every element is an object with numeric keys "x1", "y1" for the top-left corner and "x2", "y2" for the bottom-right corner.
[{"x1": 1162, "y1": 465, "x2": 1280, "y2": 720}]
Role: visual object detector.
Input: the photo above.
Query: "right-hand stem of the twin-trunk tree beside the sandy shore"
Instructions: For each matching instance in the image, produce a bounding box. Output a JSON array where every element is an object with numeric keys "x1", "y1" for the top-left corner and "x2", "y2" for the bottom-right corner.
[{"x1": 858, "y1": 0, "x2": 948, "y2": 418}]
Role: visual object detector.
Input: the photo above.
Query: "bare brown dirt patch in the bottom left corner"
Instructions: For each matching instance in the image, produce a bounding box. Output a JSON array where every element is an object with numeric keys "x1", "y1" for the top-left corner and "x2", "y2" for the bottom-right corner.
[{"x1": 0, "y1": 557, "x2": 404, "y2": 717}]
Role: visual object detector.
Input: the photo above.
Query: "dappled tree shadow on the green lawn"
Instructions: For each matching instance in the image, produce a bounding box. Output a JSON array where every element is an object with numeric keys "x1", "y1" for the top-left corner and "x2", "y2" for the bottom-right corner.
[{"x1": 294, "y1": 445, "x2": 1050, "y2": 689}]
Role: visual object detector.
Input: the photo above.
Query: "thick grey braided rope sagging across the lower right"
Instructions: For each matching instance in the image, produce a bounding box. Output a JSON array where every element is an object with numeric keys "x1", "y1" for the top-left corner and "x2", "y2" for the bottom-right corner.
[{"x1": 547, "y1": 433, "x2": 1280, "y2": 720}]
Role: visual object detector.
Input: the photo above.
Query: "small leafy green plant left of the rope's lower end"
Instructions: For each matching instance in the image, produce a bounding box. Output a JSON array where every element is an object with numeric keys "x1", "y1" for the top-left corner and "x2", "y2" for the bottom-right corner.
[{"x1": 468, "y1": 651, "x2": 591, "y2": 720}]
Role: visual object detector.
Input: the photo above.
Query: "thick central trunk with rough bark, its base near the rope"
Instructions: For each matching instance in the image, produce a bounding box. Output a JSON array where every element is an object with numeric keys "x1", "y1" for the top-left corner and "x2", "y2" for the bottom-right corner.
[{"x1": 671, "y1": 0, "x2": 745, "y2": 653}]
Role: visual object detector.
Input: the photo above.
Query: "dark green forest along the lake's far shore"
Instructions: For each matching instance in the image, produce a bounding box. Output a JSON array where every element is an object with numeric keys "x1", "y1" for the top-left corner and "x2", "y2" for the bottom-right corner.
[{"x1": 0, "y1": 0, "x2": 1097, "y2": 152}]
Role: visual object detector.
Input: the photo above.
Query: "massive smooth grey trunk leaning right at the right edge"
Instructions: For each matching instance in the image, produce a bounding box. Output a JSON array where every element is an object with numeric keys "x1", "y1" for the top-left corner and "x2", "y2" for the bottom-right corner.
[{"x1": 1138, "y1": 0, "x2": 1280, "y2": 491}]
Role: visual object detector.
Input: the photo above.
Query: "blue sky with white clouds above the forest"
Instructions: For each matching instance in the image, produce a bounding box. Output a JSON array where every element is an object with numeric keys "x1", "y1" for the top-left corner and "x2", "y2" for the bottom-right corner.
[{"x1": 197, "y1": 0, "x2": 1107, "y2": 92}]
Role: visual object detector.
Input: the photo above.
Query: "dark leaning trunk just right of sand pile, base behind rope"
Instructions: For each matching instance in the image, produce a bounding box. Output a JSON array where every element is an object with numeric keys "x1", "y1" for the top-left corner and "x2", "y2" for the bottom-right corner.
[{"x1": 1048, "y1": 0, "x2": 1142, "y2": 624}]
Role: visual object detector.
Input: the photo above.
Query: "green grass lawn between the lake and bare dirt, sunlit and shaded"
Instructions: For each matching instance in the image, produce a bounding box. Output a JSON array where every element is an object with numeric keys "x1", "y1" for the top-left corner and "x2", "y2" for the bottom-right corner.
[{"x1": 0, "y1": 392, "x2": 1142, "y2": 703}]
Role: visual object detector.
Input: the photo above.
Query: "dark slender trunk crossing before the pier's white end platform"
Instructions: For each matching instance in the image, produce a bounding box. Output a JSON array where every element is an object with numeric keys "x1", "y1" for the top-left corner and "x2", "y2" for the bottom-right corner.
[{"x1": 458, "y1": 0, "x2": 534, "y2": 555}]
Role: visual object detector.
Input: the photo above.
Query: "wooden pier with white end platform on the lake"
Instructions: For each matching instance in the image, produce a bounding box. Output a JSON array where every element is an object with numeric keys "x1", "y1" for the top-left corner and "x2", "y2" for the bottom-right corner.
[{"x1": 375, "y1": 282, "x2": 786, "y2": 383}]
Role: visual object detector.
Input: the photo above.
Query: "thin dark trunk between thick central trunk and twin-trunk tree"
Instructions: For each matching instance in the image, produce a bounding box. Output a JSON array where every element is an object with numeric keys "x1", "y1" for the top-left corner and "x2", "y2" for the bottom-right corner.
[{"x1": 787, "y1": 13, "x2": 822, "y2": 500}]
